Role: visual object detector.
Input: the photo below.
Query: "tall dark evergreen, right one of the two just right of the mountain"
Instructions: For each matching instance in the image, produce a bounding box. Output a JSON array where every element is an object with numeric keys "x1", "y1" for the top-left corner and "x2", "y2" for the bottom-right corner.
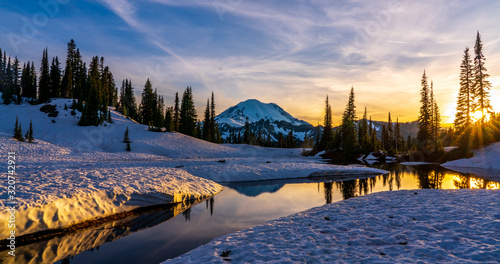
[{"x1": 341, "y1": 87, "x2": 357, "y2": 160}]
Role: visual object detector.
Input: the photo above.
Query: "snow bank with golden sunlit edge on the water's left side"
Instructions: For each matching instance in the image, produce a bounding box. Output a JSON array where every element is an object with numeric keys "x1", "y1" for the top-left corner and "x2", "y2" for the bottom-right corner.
[{"x1": 0, "y1": 164, "x2": 223, "y2": 239}]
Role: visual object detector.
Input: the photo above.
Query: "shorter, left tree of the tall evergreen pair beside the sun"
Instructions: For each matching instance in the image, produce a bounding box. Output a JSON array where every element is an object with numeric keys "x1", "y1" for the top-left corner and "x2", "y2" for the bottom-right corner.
[{"x1": 454, "y1": 47, "x2": 474, "y2": 152}]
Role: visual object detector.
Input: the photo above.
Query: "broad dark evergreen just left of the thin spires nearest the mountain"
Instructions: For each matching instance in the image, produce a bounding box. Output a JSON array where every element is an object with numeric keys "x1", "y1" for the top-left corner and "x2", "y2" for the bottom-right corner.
[{"x1": 178, "y1": 86, "x2": 197, "y2": 136}]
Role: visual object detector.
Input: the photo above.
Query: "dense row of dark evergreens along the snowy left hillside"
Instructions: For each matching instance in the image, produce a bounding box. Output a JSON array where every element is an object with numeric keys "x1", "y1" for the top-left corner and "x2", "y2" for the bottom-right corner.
[{"x1": 0, "y1": 39, "x2": 222, "y2": 142}]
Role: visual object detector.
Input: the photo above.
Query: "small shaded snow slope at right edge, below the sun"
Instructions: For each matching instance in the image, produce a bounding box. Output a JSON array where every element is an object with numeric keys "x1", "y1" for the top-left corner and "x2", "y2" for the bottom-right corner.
[{"x1": 441, "y1": 142, "x2": 500, "y2": 174}]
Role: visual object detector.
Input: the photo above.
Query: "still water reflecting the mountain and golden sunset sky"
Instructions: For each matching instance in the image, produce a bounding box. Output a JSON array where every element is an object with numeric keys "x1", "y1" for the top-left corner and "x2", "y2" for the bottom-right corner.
[{"x1": 21, "y1": 164, "x2": 500, "y2": 264}]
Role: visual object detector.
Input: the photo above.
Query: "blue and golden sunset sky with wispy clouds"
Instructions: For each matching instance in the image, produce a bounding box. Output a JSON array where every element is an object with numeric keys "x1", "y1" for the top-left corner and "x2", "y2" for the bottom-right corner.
[{"x1": 0, "y1": 0, "x2": 500, "y2": 124}]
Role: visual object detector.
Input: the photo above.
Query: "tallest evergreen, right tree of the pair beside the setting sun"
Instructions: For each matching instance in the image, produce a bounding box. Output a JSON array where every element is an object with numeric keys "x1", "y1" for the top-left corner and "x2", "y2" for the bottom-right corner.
[{"x1": 473, "y1": 31, "x2": 493, "y2": 127}]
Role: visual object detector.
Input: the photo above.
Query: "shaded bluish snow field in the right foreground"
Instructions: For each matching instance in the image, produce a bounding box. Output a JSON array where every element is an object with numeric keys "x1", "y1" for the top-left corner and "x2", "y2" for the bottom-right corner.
[{"x1": 163, "y1": 190, "x2": 500, "y2": 263}]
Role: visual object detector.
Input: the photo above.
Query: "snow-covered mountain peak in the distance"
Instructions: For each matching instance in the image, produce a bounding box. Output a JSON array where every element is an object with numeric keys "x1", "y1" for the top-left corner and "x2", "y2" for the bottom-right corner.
[{"x1": 215, "y1": 99, "x2": 314, "y2": 144}]
